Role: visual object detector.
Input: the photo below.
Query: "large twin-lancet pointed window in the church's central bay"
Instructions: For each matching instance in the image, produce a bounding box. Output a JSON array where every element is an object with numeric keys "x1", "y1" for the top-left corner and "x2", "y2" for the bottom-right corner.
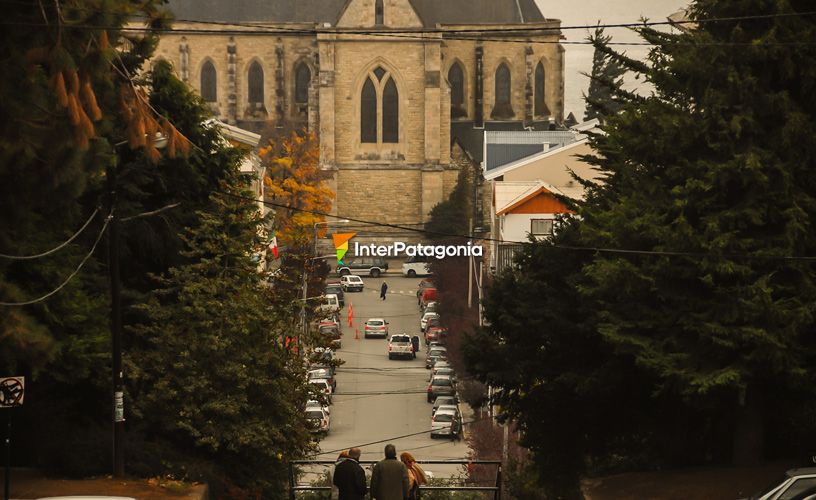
[{"x1": 360, "y1": 66, "x2": 399, "y2": 144}]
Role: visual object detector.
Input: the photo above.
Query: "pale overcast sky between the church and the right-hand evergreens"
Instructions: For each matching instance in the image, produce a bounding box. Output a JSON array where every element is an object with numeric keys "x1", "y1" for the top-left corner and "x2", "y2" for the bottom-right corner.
[{"x1": 536, "y1": 0, "x2": 689, "y2": 121}]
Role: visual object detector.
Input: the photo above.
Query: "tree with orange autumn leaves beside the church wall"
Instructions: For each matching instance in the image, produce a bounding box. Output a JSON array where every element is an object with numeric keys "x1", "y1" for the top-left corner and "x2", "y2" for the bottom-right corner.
[{"x1": 260, "y1": 131, "x2": 334, "y2": 249}]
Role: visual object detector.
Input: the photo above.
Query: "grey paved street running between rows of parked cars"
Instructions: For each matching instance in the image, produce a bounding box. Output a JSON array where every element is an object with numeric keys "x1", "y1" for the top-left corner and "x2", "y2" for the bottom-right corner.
[{"x1": 318, "y1": 276, "x2": 469, "y2": 477}]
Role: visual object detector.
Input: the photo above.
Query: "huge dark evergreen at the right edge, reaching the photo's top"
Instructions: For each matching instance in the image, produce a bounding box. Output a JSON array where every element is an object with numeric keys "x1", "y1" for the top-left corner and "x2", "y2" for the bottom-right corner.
[{"x1": 581, "y1": 0, "x2": 816, "y2": 462}]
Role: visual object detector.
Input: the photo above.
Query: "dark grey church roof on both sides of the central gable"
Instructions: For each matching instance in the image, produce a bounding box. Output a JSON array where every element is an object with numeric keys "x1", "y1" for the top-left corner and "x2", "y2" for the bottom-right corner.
[{"x1": 168, "y1": 0, "x2": 545, "y2": 28}]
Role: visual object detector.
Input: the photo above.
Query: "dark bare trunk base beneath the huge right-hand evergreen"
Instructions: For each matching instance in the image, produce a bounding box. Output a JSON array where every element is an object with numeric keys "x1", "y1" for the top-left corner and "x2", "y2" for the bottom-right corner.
[{"x1": 731, "y1": 386, "x2": 765, "y2": 465}]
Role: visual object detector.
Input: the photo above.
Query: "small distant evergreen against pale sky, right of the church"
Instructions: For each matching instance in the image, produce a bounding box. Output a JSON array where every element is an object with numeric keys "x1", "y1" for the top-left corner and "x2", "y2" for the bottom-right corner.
[{"x1": 584, "y1": 27, "x2": 626, "y2": 121}]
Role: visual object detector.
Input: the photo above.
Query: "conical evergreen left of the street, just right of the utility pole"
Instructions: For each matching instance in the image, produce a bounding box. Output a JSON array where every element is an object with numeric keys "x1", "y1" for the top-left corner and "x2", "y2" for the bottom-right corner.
[{"x1": 131, "y1": 184, "x2": 309, "y2": 498}]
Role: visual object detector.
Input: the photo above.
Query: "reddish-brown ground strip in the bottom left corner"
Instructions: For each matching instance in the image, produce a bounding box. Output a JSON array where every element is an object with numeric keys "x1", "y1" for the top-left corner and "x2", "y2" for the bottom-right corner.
[{"x1": 0, "y1": 469, "x2": 209, "y2": 500}]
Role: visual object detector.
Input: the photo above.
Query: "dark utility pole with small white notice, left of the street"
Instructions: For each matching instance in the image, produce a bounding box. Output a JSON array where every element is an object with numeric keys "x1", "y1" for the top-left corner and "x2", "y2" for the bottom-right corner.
[{"x1": 106, "y1": 159, "x2": 125, "y2": 477}]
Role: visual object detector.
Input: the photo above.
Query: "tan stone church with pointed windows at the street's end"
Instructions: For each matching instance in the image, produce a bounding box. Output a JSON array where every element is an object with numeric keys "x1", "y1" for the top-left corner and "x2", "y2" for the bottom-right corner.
[{"x1": 151, "y1": 0, "x2": 564, "y2": 234}]
